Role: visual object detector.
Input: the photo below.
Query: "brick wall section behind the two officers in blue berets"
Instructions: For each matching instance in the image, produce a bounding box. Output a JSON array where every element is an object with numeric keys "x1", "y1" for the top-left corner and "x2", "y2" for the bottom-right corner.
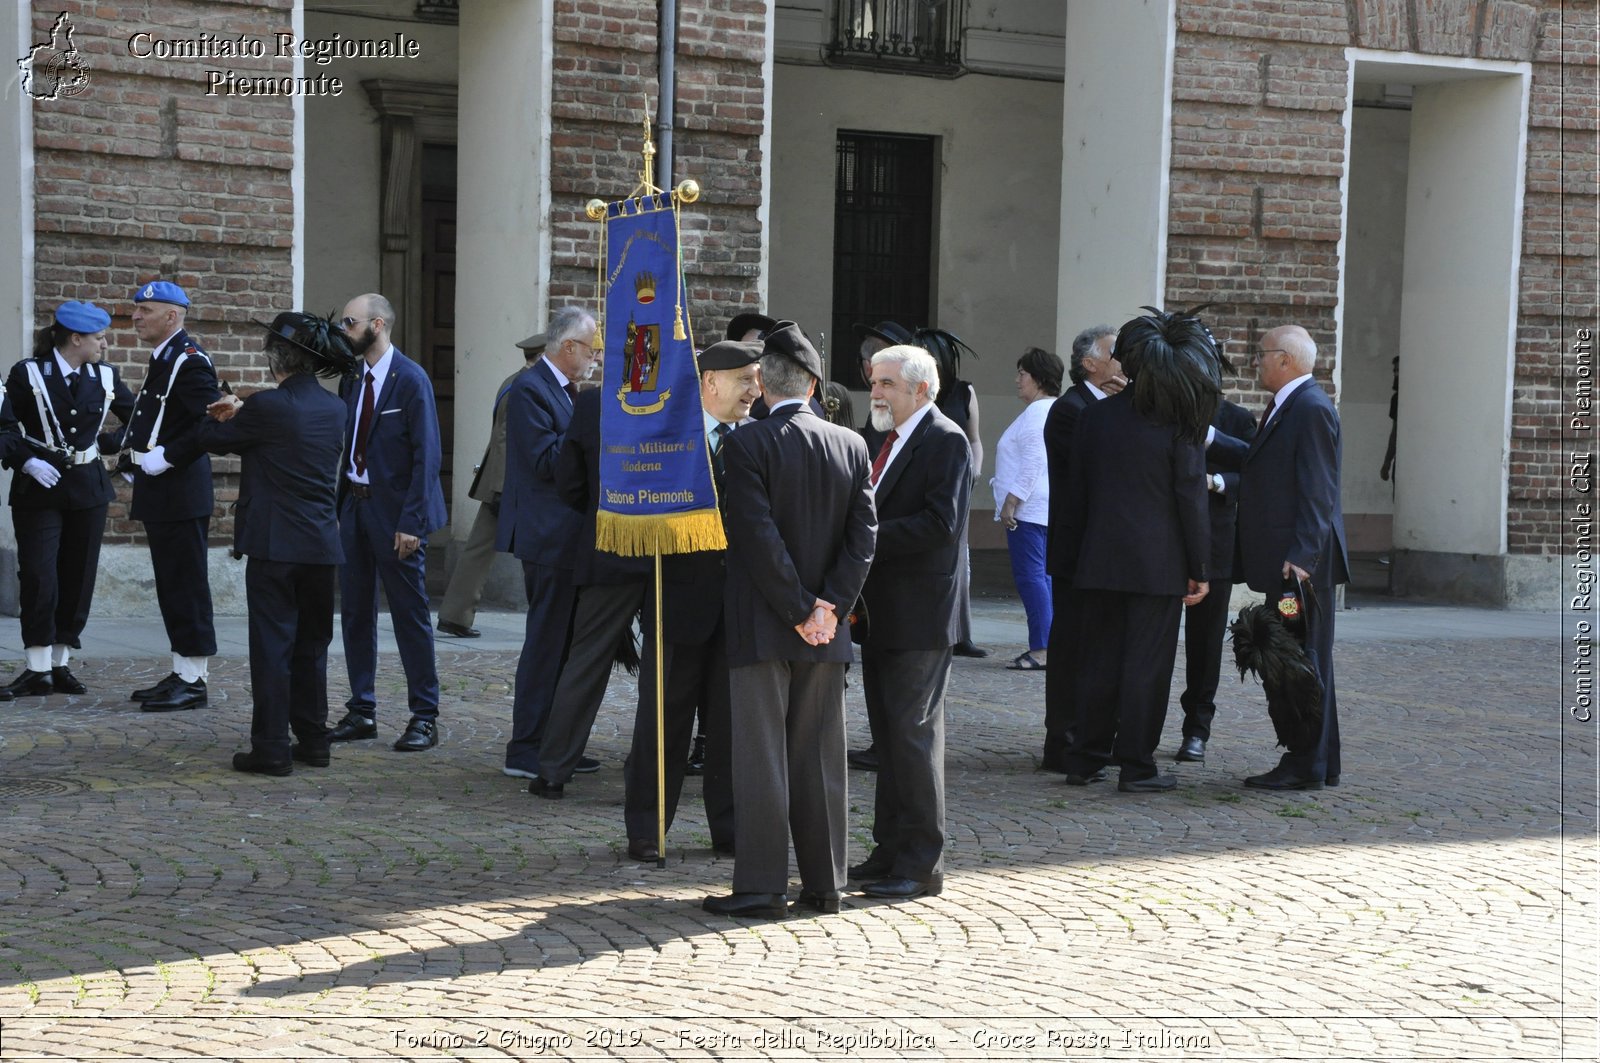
[{"x1": 32, "y1": 0, "x2": 299, "y2": 543}]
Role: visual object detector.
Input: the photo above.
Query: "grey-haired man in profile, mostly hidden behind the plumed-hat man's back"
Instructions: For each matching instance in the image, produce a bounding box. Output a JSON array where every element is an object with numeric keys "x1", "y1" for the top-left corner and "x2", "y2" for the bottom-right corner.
[{"x1": 1038, "y1": 325, "x2": 1128, "y2": 772}]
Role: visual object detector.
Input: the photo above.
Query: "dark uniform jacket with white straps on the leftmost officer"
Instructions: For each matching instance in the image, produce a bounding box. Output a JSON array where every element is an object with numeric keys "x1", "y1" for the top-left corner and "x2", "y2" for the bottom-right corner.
[{"x1": 0, "y1": 355, "x2": 133, "y2": 509}]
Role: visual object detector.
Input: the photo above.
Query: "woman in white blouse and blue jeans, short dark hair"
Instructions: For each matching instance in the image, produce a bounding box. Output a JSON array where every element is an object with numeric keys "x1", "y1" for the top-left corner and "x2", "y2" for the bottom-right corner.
[{"x1": 989, "y1": 347, "x2": 1062, "y2": 672}]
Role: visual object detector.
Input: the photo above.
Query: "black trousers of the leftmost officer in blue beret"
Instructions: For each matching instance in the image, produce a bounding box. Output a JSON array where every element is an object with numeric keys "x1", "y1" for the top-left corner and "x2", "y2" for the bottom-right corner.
[{"x1": 11, "y1": 505, "x2": 106, "y2": 648}]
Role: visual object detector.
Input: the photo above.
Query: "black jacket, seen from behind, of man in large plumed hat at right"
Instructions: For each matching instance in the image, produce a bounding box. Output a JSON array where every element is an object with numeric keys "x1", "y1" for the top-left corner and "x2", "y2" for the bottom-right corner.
[{"x1": 1062, "y1": 389, "x2": 1211, "y2": 597}]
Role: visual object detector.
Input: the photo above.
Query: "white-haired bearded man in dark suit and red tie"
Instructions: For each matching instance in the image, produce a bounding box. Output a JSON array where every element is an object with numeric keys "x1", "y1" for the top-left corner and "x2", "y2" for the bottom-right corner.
[{"x1": 850, "y1": 346, "x2": 973, "y2": 900}]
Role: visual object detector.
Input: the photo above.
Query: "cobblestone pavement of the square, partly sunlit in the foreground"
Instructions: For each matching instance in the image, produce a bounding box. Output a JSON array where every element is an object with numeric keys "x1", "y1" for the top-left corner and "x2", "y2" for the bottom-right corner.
[{"x1": 0, "y1": 607, "x2": 1600, "y2": 1060}]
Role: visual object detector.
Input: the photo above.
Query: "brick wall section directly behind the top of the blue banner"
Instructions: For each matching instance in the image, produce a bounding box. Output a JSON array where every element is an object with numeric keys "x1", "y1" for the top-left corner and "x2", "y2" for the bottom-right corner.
[{"x1": 550, "y1": 0, "x2": 766, "y2": 344}]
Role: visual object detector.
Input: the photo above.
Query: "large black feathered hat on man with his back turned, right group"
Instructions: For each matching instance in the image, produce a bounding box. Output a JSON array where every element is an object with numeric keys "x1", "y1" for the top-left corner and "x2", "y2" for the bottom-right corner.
[{"x1": 1112, "y1": 306, "x2": 1222, "y2": 443}]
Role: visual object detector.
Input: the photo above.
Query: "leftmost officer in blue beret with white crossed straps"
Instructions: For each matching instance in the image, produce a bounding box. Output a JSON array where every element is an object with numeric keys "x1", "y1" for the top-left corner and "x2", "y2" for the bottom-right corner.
[{"x1": 0, "y1": 303, "x2": 133, "y2": 701}]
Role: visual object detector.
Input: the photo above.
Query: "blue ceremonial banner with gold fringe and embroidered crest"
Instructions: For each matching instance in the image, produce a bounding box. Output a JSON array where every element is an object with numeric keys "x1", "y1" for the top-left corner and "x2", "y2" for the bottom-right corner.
[{"x1": 595, "y1": 192, "x2": 728, "y2": 557}]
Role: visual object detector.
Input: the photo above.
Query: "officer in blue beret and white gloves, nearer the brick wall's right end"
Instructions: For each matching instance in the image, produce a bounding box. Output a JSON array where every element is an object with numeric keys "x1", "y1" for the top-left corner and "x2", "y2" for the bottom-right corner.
[{"x1": 120, "y1": 280, "x2": 219, "y2": 712}]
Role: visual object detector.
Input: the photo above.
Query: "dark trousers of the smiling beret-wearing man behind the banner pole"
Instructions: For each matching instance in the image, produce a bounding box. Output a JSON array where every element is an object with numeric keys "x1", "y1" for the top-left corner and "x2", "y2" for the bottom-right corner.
[{"x1": 622, "y1": 608, "x2": 734, "y2": 847}]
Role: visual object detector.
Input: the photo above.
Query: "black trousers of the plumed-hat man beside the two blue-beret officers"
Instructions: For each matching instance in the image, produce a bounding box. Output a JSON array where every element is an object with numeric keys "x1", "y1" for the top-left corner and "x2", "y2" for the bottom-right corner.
[{"x1": 245, "y1": 557, "x2": 338, "y2": 764}]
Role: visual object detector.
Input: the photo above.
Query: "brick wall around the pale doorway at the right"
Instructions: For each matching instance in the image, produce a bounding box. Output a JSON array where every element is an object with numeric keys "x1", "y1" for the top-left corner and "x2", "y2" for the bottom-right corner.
[{"x1": 1166, "y1": 0, "x2": 1597, "y2": 554}]
